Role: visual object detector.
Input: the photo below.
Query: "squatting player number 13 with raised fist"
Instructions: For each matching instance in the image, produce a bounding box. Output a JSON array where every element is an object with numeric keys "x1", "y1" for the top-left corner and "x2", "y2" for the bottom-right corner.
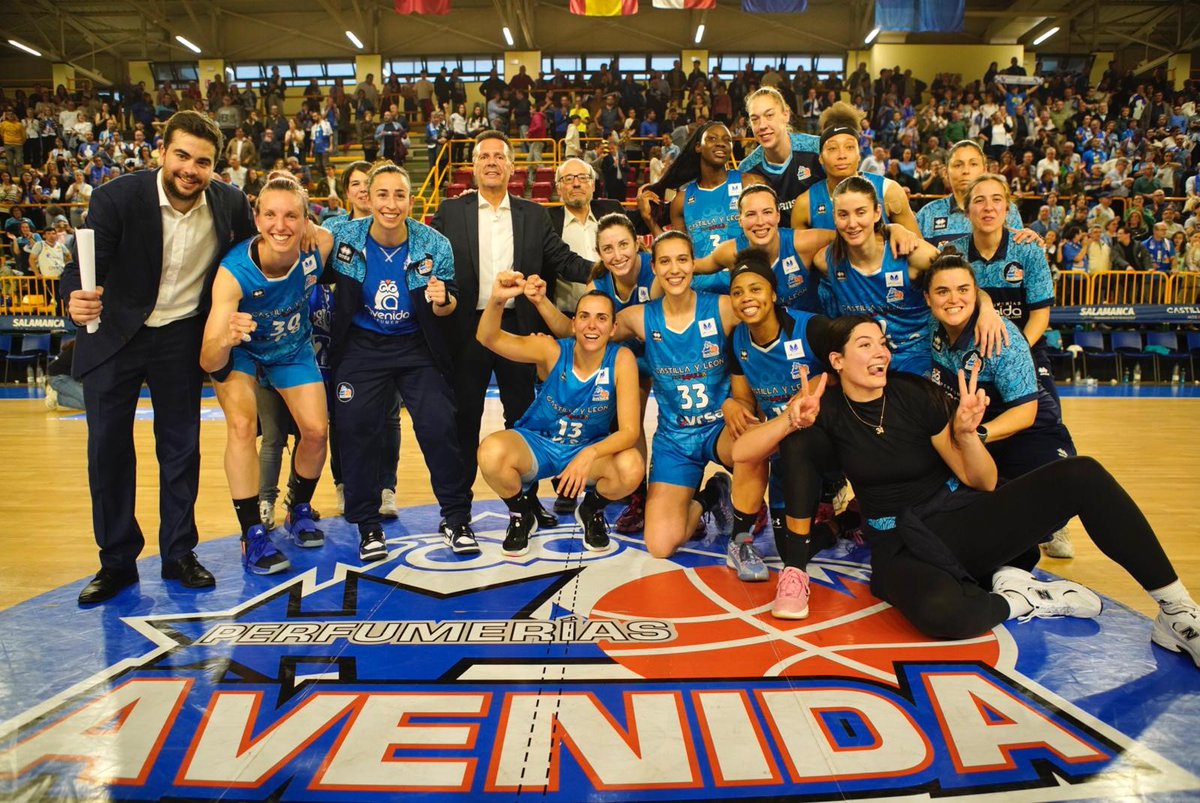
[{"x1": 475, "y1": 271, "x2": 646, "y2": 556}]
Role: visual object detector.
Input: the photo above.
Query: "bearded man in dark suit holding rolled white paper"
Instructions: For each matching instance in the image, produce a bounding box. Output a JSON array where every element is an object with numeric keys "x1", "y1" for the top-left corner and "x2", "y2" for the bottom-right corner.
[{"x1": 62, "y1": 112, "x2": 254, "y2": 605}]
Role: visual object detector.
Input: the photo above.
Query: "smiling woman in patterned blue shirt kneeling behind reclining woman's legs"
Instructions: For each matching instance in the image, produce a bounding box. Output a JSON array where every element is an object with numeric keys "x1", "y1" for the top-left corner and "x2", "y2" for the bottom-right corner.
[{"x1": 925, "y1": 247, "x2": 1076, "y2": 558}]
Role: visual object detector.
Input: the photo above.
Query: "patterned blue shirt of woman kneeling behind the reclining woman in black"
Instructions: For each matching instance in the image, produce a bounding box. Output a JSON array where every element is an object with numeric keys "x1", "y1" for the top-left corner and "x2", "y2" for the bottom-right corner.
[{"x1": 929, "y1": 312, "x2": 1062, "y2": 431}]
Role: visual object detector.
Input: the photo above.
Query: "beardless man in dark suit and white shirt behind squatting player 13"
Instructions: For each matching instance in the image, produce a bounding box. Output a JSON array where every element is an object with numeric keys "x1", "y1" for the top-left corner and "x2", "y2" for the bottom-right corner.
[{"x1": 433, "y1": 131, "x2": 592, "y2": 506}]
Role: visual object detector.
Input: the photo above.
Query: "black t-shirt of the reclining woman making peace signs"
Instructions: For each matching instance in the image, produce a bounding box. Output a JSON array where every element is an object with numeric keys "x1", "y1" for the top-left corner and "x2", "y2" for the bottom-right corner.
[{"x1": 816, "y1": 372, "x2": 953, "y2": 519}]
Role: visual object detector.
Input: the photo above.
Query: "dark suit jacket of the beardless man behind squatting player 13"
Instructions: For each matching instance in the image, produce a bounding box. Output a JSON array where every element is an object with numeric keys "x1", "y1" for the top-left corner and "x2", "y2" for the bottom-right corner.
[{"x1": 432, "y1": 192, "x2": 592, "y2": 348}]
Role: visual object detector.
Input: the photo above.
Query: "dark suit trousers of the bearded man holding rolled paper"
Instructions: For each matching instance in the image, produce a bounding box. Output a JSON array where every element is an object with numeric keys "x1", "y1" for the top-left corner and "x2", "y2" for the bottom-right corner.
[{"x1": 83, "y1": 316, "x2": 204, "y2": 571}]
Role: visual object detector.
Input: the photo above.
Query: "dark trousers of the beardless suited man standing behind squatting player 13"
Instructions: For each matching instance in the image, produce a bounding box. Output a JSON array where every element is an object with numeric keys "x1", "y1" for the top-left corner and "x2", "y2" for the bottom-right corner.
[{"x1": 451, "y1": 310, "x2": 538, "y2": 501}]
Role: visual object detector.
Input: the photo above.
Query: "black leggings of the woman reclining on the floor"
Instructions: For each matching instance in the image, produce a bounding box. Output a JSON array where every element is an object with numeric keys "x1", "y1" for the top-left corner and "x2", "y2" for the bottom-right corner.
[{"x1": 780, "y1": 439, "x2": 1177, "y2": 639}]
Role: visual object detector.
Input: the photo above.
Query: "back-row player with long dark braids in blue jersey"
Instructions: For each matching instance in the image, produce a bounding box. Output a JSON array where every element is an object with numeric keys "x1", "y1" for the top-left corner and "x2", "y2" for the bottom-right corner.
[{"x1": 637, "y1": 122, "x2": 742, "y2": 258}]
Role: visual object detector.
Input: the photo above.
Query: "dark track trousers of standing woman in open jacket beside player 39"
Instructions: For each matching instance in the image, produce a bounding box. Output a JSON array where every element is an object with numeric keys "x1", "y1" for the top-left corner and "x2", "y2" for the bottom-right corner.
[{"x1": 334, "y1": 328, "x2": 474, "y2": 527}]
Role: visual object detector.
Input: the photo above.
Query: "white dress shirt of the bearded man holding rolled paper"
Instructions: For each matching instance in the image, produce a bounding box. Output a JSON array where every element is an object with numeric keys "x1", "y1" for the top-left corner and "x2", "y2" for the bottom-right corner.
[{"x1": 146, "y1": 168, "x2": 217, "y2": 326}]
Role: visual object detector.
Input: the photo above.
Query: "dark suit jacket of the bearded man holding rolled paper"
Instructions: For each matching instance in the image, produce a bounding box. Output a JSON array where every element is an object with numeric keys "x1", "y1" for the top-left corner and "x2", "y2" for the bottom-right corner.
[{"x1": 61, "y1": 170, "x2": 254, "y2": 377}]
